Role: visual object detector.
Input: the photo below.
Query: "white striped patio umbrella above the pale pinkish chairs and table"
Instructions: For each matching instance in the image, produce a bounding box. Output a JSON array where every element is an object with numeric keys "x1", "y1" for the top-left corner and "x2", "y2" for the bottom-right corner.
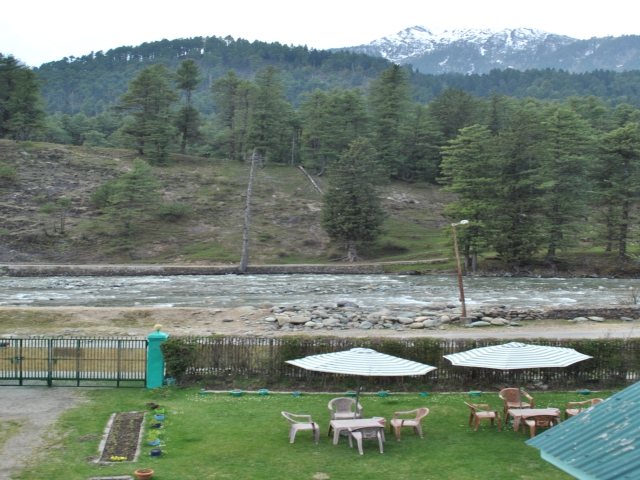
[{"x1": 286, "y1": 348, "x2": 436, "y2": 416}]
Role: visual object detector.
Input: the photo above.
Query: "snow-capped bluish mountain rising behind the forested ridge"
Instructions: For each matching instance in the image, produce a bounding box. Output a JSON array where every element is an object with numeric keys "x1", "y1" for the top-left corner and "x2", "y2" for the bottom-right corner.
[{"x1": 338, "y1": 25, "x2": 640, "y2": 74}]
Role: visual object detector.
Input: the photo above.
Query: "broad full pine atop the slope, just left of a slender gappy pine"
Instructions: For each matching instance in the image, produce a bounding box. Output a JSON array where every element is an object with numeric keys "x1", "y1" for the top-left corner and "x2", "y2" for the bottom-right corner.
[{"x1": 113, "y1": 63, "x2": 179, "y2": 165}]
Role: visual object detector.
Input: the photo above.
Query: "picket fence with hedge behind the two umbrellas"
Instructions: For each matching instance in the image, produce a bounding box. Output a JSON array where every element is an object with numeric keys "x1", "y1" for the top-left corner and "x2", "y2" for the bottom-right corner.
[{"x1": 181, "y1": 337, "x2": 640, "y2": 389}]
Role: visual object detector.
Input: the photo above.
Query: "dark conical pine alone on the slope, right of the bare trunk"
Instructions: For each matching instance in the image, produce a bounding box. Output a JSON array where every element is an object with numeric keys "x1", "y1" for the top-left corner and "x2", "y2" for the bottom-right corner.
[{"x1": 322, "y1": 138, "x2": 386, "y2": 262}]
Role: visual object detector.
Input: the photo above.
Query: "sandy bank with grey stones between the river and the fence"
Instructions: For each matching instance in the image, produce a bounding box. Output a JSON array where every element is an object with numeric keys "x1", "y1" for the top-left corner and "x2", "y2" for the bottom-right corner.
[{"x1": 0, "y1": 302, "x2": 640, "y2": 339}]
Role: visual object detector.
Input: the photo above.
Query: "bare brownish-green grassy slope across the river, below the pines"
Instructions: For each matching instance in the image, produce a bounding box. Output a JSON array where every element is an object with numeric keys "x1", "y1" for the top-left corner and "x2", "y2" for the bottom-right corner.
[{"x1": 0, "y1": 140, "x2": 639, "y2": 275}]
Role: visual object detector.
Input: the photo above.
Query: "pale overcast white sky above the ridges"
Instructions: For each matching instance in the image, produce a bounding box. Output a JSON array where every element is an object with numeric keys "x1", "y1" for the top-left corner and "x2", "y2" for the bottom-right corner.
[{"x1": 0, "y1": 0, "x2": 640, "y2": 66}]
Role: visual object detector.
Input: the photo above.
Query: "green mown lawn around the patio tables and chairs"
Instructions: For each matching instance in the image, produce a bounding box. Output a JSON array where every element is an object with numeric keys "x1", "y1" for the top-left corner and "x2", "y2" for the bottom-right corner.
[{"x1": 14, "y1": 387, "x2": 596, "y2": 480}]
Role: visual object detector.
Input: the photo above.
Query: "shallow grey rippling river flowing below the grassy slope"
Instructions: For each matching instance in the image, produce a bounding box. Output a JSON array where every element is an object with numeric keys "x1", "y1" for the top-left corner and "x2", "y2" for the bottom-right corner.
[{"x1": 0, "y1": 275, "x2": 640, "y2": 308}]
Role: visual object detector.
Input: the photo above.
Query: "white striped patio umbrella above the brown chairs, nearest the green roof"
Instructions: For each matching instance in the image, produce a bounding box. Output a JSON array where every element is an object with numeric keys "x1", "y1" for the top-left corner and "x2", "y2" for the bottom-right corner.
[{"x1": 444, "y1": 342, "x2": 593, "y2": 406}]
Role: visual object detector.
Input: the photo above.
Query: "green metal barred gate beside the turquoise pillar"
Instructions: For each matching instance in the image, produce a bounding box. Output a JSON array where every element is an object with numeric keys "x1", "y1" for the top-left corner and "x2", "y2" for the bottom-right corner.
[{"x1": 0, "y1": 337, "x2": 147, "y2": 388}]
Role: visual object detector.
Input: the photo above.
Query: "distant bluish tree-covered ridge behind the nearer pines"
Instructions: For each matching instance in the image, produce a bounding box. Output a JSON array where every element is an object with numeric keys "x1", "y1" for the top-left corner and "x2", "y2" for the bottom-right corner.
[{"x1": 34, "y1": 37, "x2": 640, "y2": 117}]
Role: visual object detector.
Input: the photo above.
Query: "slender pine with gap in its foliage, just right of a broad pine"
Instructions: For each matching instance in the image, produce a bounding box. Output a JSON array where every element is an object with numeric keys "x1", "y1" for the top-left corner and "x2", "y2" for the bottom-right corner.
[{"x1": 175, "y1": 58, "x2": 202, "y2": 154}]
